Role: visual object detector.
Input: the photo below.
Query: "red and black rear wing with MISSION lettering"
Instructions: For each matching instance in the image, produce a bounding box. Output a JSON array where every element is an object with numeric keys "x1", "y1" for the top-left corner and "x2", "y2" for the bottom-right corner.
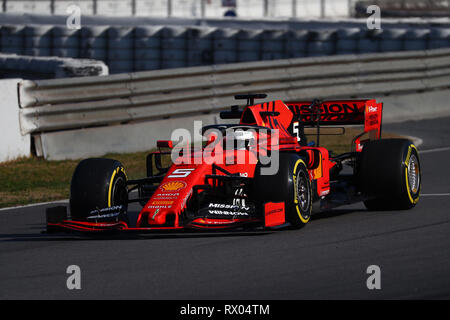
[{"x1": 285, "y1": 99, "x2": 383, "y2": 139}]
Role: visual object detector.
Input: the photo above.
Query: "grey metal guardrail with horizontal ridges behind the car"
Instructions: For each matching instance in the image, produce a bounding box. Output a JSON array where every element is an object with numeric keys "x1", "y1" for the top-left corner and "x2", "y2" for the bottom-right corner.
[{"x1": 19, "y1": 49, "x2": 450, "y2": 134}]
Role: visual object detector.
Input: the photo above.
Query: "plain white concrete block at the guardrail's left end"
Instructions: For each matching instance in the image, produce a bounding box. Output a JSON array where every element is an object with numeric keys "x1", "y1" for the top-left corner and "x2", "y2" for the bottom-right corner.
[{"x1": 0, "y1": 79, "x2": 30, "y2": 162}]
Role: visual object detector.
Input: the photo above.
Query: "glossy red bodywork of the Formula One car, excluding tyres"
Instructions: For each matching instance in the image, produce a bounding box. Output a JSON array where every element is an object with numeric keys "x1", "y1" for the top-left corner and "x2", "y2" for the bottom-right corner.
[{"x1": 46, "y1": 100, "x2": 383, "y2": 231}]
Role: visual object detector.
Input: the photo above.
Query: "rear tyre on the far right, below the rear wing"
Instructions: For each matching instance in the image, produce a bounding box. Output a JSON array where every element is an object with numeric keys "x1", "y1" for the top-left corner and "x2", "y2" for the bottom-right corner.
[{"x1": 358, "y1": 139, "x2": 422, "y2": 210}]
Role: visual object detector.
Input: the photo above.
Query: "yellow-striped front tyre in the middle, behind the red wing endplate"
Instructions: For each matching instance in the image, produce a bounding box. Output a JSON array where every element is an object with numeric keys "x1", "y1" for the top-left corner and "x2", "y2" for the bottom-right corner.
[{"x1": 253, "y1": 153, "x2": 312, "y2": 229}]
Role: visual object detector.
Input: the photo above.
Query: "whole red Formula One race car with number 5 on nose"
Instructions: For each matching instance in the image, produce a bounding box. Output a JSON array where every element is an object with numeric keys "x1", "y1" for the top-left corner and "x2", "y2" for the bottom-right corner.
[{"x1": 47, "y1": 94, "x2": 421, "y2": 232}]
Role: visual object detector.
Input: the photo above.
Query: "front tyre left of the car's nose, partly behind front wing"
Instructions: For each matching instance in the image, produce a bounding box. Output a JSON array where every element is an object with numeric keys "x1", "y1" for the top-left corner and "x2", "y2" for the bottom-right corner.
[{"x1": 70, "y1": 158, "x2": 128, "y2": 220}]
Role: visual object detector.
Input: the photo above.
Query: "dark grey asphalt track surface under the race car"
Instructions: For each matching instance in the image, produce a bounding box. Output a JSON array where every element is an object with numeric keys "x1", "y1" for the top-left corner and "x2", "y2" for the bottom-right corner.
[{"x1": 0, "y1": 118, "x2": 450, "y2": 300}]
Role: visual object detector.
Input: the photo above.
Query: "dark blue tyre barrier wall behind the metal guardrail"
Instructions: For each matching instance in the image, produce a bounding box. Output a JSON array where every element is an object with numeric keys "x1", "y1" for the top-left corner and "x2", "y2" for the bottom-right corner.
[{"x1": 0, "y1": 25, "x2": 450, "y2": 73}]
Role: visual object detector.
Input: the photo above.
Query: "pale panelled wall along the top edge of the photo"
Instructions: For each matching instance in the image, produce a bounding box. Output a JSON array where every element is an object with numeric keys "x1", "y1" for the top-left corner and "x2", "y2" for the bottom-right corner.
[{"x1": 3, "y1": 0, "x2": 354, "y2": 18}]
